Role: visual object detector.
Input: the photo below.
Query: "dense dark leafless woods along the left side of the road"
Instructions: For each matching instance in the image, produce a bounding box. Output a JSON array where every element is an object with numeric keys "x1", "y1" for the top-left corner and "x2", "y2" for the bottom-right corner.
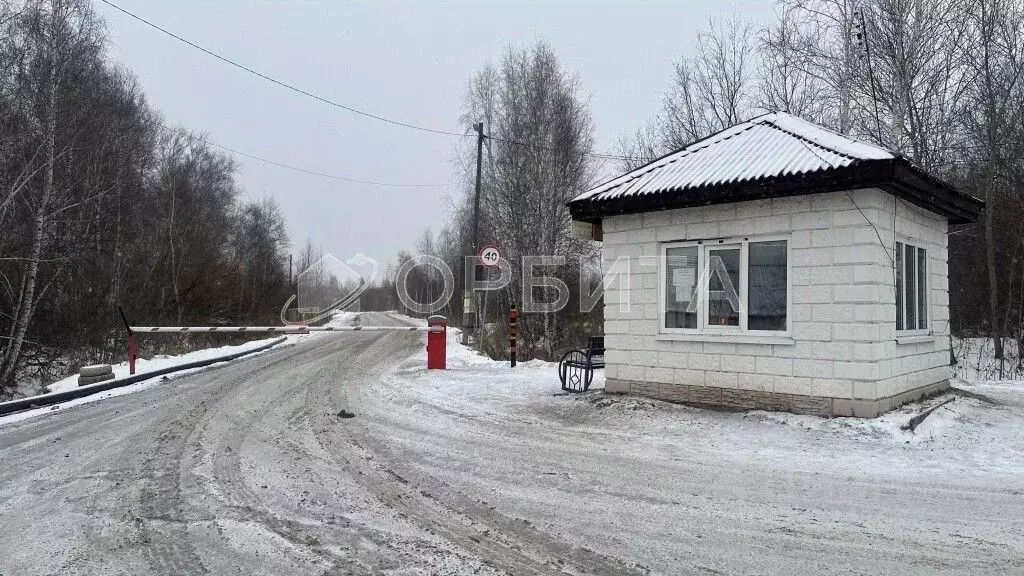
[{"x1": 0, "y1": 0, "x2": 290, "y2": 397}]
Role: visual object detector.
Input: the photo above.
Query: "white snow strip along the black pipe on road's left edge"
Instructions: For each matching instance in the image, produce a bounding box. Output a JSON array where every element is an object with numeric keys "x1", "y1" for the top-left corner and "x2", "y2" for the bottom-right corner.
[{"x1": 0, "y1": 312, "x2": 358, "y2": 426}]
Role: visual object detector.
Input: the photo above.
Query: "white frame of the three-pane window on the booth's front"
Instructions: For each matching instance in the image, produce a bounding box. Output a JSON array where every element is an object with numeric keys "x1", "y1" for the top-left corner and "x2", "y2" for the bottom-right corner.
[{"x1": 657, "y1": 235, "x2": 793, "y2": 338}]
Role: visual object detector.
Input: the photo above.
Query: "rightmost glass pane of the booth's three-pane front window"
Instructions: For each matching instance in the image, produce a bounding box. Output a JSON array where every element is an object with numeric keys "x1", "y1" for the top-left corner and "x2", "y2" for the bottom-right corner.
[{"x1": 746, "y1": 240, "x2": 787, "y2": 330}]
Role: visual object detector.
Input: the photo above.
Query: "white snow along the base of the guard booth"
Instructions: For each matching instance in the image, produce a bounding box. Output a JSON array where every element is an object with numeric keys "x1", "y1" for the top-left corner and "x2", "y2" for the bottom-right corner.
[{"x1": 409, "y1": 329, "x2": 1024, "y2": 457}]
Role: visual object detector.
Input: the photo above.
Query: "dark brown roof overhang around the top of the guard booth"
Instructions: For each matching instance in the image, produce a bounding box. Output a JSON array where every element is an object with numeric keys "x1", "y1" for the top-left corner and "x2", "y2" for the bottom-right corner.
[{"x1": 568, "y1": 158, "x2": 984, "y2": 224}]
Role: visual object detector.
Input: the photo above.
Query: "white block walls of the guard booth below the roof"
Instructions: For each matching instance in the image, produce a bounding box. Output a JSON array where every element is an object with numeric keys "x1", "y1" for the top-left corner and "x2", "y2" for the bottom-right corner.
[{"x1": 603, "y1": 190, "x2": 949, "y2": 413}]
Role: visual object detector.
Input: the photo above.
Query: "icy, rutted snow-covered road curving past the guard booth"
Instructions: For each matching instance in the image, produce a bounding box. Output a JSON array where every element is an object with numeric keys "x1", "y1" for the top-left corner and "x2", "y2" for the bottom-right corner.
[{"x1": 0, "y1": 314, "x2": 1024, "y2": 576}]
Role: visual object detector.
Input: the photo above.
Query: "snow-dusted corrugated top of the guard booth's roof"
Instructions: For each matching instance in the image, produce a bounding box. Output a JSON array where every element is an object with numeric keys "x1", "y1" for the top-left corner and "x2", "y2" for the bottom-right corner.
[{"x1": 573, "y1": 112, "x2": 896, "y2": 202}]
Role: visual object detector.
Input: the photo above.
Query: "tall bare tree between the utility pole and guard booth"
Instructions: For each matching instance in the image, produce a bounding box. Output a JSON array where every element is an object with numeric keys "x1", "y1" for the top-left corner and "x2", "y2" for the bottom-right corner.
[{"x1": 461, "y1": 42, "x2": 594, "y2": 358}]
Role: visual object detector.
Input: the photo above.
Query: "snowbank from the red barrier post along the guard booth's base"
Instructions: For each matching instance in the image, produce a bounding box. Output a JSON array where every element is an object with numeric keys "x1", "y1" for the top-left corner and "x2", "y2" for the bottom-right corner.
[{"x1": 385, "y1": 317, "x2": 1024, "y2": 465}]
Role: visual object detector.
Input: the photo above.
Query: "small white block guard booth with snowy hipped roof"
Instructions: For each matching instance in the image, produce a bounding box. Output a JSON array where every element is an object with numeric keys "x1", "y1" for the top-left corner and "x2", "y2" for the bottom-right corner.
[{"x1": 570, "y1": 114, "x2": 982, "y2": 416}]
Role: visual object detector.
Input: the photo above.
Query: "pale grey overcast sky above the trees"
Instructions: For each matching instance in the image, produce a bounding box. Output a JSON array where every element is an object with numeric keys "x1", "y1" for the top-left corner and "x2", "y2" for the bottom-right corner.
[{"x1": 96, "y1": 0, "x2": 773, "y2": 260}]
